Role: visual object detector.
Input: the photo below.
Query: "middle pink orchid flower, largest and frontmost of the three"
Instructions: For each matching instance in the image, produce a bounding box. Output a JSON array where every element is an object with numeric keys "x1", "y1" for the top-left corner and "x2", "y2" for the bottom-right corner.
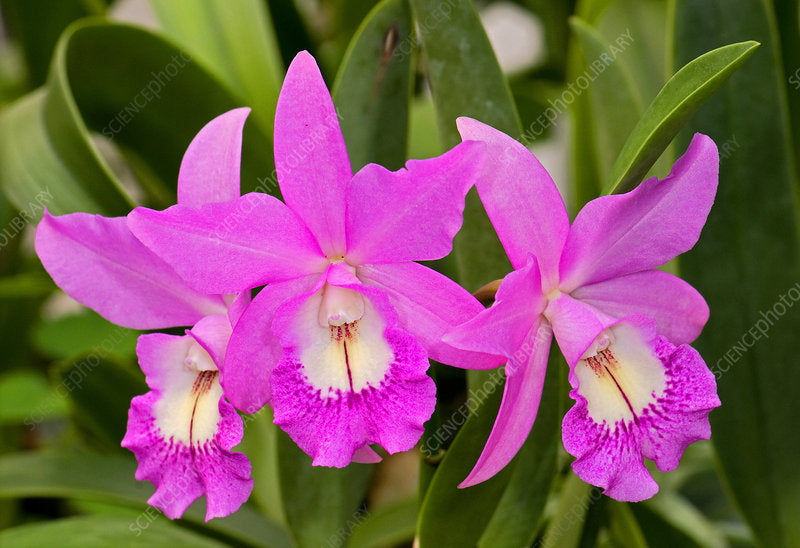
[{"x1": 128, "y1": 52, "x2": 502, "y2": 467}]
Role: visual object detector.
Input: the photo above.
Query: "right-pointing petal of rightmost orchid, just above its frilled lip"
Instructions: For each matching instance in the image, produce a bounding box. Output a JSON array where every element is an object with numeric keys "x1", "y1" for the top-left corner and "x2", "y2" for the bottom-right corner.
[{"x1": 572, "y1": 270, "x2": 708, "y2": 344}]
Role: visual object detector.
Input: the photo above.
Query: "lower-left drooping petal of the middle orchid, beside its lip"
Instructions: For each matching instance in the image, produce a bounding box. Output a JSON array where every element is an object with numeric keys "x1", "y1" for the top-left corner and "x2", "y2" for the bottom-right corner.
[{"x1": 222, "y1": 274, "x2": 319, "y2": 414}]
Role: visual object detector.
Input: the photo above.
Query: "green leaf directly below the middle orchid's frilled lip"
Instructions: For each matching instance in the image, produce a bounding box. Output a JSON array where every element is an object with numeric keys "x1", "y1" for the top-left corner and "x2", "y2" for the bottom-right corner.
[{"x1": 276, "y1": 430, "x2": 372, "y2": 548}]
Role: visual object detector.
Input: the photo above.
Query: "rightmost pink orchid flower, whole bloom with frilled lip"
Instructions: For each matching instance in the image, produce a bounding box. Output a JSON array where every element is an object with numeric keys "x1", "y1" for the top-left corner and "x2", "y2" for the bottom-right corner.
[{"x1": 444, "y1": 118, "x2": 720, "y2": 501}]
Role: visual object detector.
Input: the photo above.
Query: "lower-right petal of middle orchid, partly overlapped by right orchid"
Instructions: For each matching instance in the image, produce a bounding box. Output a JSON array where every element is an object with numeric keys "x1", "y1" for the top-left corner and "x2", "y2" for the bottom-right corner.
[{"x1": 356, "y1": 263, "x2": 506, "y2": 369}]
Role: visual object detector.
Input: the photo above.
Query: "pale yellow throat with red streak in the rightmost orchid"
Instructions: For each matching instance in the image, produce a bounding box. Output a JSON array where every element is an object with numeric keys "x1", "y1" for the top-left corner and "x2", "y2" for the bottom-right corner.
[{"x1": 575, "y1": 324, "x2": 666, "y2": 425}]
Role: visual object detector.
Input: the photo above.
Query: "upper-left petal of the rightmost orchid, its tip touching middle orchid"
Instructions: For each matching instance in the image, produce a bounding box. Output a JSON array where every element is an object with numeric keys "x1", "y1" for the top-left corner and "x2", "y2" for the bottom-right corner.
[{"x1": 456, "y1": 118, "x2": 569, "y2": 287}]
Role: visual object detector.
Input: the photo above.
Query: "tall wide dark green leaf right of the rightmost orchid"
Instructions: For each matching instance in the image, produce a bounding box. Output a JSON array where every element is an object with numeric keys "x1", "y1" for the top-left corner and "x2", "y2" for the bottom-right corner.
[{"x1": 673, "y1": 0, "x2": 800, "y2": 547}]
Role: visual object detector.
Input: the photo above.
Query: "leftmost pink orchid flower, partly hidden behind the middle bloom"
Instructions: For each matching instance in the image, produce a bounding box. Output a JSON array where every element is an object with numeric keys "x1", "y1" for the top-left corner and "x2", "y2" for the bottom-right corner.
[{"x1": 36, "y1": 108, "x2": 253, "y2": 520}]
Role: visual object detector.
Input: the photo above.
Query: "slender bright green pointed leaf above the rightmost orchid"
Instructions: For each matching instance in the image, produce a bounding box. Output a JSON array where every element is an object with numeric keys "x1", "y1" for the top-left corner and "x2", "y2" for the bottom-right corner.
[{"x1": 604, "y1": 41, "x2": 759, "y2": 194}]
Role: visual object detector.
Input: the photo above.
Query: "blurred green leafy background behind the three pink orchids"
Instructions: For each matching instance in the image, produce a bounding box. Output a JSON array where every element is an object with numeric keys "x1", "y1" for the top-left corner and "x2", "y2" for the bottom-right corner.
[{"x1": 0, "y1": 0, "x2": 800, "y2": 547}]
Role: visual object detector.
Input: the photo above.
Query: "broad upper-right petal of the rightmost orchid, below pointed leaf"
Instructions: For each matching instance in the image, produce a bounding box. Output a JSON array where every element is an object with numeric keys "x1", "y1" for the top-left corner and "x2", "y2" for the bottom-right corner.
[{"x1": 561, "y1": 133, "x2": 719, "y2": 292}]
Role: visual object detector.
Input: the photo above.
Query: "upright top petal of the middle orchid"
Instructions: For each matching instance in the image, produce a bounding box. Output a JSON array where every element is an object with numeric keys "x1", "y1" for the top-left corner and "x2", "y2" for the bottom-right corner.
[{"x1": 275, "y1": 51, "x2": 353, "y2": 257}]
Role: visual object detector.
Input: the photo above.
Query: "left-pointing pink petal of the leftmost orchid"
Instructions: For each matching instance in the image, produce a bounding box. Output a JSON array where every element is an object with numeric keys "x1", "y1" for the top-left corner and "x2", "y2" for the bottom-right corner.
[{"x1": 36, "y1": 211, "x2": 225, "y2": 329}]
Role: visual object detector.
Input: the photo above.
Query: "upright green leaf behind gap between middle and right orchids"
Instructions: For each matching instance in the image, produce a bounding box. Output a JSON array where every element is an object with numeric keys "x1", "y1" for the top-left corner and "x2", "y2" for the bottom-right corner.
[{"x1": 411, "y1": 0, "x2": 522, "y2": 291}]
